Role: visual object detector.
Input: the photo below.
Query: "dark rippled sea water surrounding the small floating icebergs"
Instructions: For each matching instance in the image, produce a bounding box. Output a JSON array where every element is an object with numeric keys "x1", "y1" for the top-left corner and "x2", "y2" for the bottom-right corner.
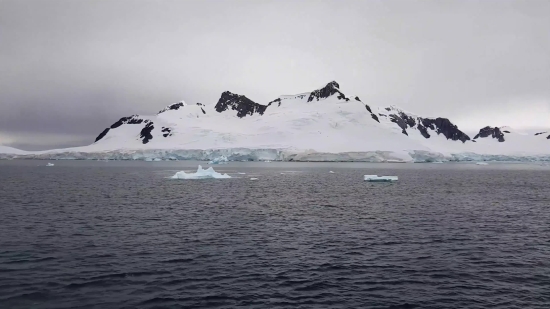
[{"x1": 0, "y1": 161, "x2": 550, "y2": 309}]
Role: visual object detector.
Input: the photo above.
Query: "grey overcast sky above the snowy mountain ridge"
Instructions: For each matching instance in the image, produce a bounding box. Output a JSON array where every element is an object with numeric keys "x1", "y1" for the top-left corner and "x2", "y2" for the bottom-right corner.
[{"x1": 0, "y1": 0, "x2": 550, "y2": 150}]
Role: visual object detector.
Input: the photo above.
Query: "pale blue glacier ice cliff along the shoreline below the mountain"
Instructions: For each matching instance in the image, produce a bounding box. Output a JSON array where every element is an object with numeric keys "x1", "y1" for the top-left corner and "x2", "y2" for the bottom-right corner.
[{"x1": 4, "y1": 148, "x2": 550, "y2": 163}]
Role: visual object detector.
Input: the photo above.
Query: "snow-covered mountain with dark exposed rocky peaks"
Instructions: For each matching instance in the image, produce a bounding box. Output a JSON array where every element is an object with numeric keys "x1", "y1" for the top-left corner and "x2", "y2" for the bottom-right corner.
[{"x1": 0, "y1": 81, "x2": 550, "y2": 161}]
